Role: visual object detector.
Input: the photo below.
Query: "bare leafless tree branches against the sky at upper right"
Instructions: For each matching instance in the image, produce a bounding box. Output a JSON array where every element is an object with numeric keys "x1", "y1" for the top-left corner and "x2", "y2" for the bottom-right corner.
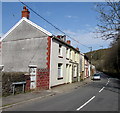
[{"x1": 95, "y1": 0, "x2": 120, "y2": 40}]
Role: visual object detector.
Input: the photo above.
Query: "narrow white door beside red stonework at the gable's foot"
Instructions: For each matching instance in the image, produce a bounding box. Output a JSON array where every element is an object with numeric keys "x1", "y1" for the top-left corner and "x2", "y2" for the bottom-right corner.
[{"x1": 30, "y1": 67, "x2": 37, "y2": 89}]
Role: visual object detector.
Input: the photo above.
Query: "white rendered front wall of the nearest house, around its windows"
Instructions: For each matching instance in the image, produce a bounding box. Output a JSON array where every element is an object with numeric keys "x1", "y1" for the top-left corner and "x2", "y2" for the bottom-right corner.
[{"x1": 50, "y1": 40, "x2": 69, "y2": 87}]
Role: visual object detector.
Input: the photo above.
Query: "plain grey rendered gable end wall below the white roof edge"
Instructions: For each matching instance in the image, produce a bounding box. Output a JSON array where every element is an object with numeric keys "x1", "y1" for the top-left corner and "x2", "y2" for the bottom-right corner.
[{"x1": 2, "y1": 21, "x2": 48, "y2": 72}]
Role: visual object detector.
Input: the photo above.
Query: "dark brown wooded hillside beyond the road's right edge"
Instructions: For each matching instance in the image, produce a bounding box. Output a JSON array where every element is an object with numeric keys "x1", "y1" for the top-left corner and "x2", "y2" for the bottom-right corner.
[{"x1": 85, "y1": 44, "x2": 120, "y2": 79}]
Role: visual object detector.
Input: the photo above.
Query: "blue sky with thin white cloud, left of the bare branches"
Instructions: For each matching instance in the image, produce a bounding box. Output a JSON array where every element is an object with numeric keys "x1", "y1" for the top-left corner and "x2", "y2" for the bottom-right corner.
[{"x1": 1, "y1": 2, "x2": 110, "y2": 53}]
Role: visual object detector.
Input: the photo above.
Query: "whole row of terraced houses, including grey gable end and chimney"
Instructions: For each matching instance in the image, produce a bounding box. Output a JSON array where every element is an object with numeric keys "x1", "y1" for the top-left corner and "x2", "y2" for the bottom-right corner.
[{"x1": 0, "y1": 6, "x2": 95, "y2": 89}]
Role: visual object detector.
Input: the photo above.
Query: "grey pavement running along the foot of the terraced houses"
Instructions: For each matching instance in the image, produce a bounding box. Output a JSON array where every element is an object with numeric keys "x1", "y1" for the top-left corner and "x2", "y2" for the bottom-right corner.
[{"x1": 0, "y1": 77, "x2": 92, "y2": 109}]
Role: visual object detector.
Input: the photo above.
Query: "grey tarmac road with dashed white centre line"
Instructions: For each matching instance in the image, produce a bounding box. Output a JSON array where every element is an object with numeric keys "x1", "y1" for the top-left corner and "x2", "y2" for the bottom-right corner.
[{"x1": 4, "y1": 74, "x2": 120, "y2": 111}]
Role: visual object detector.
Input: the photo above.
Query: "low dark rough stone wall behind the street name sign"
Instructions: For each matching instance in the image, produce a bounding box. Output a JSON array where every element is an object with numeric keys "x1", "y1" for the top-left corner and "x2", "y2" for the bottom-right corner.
[{"x1": 2, "y1": 72, "x2": 29, "y2": 96}]
